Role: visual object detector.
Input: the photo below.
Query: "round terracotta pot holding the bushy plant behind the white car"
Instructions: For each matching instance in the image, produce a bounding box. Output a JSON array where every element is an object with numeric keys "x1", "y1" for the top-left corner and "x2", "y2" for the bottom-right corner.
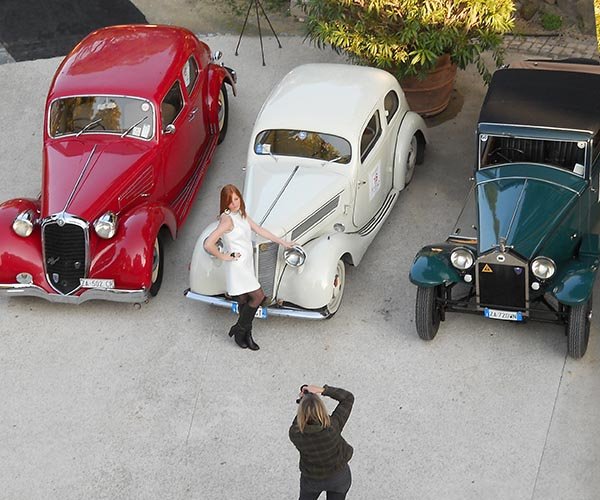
[{"x1": 400, "y1": 54, "x2": 456, "y2": 116}]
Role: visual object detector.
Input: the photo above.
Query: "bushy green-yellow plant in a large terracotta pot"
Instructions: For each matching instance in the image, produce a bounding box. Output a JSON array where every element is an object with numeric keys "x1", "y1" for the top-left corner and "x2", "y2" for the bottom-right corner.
[{"x1": 303, "y1": 0, "x2": 515, "y2": 116}]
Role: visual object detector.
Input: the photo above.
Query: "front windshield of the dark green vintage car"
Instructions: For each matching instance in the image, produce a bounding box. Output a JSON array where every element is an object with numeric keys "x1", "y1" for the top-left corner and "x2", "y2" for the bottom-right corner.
[{"x1": 479, "y1": 134, "x2": 588, "y2": 177}]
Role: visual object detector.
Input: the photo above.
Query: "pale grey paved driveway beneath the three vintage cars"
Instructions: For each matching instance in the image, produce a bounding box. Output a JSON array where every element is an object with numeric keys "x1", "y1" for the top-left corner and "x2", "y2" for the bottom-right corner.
[{"x1": 0, "y1": 36, "x2": 600, "y2": 500}]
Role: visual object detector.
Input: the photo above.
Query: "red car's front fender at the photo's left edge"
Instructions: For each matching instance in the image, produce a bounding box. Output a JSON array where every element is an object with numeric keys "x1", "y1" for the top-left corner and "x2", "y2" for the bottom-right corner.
[{"x1": 0, "y1": 198, "x2": 45, "y2": 283}]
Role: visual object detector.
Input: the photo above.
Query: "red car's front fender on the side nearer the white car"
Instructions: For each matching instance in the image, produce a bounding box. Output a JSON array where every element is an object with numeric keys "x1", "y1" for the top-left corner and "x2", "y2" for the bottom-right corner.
[{"x1": 89, "y1": 204, "x2": 177, "y2": 290}]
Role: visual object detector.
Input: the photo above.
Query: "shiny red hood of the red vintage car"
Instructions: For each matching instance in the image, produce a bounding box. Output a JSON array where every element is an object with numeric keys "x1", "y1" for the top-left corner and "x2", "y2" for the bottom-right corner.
[{"x1": 41, "y1": 138, "x2": 153, "y2": 221}]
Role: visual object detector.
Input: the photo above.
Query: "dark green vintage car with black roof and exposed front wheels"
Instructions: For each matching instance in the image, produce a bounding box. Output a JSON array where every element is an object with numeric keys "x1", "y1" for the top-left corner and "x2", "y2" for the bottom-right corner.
[{"x1": 410, "y1": 61, "x2": 600, "y2": 358}]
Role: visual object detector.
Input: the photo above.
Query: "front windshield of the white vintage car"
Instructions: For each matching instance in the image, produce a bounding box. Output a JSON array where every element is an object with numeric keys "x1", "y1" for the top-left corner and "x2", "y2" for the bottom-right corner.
[{"x1": 254, "y1": 129, "x2": 352, "y2": 163}]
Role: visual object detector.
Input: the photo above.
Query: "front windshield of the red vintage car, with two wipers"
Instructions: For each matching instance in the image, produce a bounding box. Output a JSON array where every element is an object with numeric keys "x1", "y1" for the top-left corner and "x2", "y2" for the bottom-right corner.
[{"x1": 48, "y1": 96, "x2": 154, "y2": 139}]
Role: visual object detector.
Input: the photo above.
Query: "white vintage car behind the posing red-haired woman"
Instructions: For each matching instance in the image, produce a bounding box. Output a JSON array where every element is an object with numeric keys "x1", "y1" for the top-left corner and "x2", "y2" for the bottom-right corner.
[{"x1": 186, "y1": 64, "x2": 427, "y2": 319}]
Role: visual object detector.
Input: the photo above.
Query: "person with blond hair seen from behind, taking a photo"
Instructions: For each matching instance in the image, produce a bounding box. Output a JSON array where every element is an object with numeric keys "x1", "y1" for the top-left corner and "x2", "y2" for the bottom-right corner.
[{"x1": 289, "y1": 385, "x2": 354, "y2": 500}]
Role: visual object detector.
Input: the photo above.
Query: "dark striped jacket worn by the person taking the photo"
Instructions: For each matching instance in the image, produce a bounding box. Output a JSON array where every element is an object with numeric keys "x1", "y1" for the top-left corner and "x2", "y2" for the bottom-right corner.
[{"x1": 289, "y1": 385, "x2": 354, "y2": 479}]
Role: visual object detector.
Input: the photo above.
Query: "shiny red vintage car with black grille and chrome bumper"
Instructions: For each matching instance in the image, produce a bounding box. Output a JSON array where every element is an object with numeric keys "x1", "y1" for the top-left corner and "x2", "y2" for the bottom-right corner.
[{"x1": 0, "y1": 25, "x2": 236, "y2": 303}]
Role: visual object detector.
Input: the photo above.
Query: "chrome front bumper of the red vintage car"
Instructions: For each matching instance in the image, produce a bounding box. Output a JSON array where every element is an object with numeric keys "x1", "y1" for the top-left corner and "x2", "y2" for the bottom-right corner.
[{"x1": 0, "y1": 283, "x2": 148, "y2": 304}]
